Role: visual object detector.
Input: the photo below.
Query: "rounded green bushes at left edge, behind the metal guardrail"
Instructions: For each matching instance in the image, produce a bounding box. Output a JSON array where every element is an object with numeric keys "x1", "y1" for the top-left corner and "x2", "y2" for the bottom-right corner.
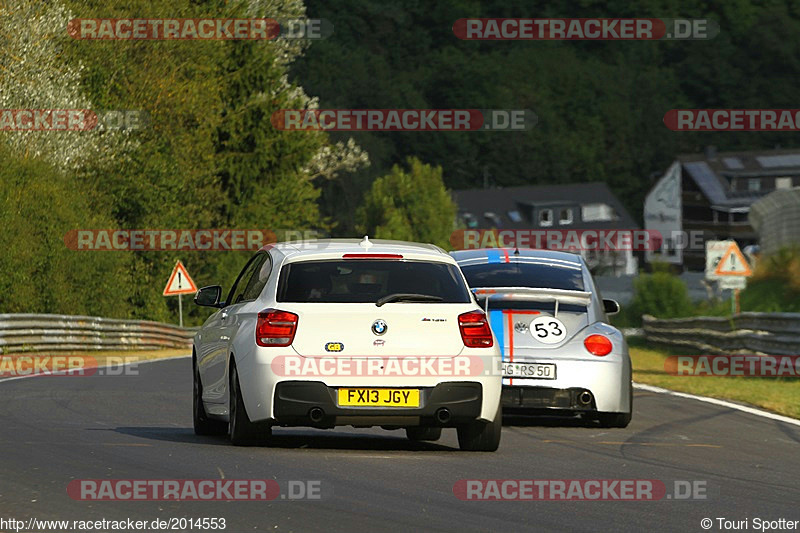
[{"x1": 0, "y1": 145, "x2": 133, "y2": 318}]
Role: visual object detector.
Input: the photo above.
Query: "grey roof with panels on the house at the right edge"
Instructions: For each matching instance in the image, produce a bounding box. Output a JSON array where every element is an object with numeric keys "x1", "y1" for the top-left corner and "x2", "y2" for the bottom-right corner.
[{"x1": 677, "y1": 149, "x2": 800, "y2": 208}]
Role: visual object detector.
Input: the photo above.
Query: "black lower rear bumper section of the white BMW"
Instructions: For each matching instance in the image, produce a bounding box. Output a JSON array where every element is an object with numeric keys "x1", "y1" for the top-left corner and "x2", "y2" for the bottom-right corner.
[{"x1": 273, "y1": 381, "x2": 484, "y2": 428}]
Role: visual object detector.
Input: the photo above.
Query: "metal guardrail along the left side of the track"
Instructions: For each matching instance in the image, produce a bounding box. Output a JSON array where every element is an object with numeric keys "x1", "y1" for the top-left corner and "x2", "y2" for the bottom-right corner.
[{"x1": 0, "y1": 314, "x2": 198, "y2": 354}]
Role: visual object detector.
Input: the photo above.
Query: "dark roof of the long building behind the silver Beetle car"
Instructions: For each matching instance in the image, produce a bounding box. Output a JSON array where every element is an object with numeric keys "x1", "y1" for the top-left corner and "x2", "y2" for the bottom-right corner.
[{"x1": 452, "y1": 182, "x2": 639, "y2": 229}]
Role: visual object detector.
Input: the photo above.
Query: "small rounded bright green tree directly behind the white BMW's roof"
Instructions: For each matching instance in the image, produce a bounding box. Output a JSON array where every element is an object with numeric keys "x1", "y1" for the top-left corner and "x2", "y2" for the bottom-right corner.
[{"x1": 356, "y1": 157, "x2": 456, "y2": 248}]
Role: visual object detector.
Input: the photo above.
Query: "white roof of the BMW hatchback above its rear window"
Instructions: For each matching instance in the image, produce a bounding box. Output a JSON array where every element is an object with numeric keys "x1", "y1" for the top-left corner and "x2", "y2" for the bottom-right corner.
[{"x1": 262, "y1": 237, "x2": 453, "y2": 263}]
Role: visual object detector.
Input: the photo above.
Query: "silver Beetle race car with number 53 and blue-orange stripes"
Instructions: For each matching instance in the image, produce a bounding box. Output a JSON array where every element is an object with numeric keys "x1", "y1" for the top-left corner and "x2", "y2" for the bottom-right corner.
[{"x1": 451, "y1": 248, "x2": 633, "y2": 427}]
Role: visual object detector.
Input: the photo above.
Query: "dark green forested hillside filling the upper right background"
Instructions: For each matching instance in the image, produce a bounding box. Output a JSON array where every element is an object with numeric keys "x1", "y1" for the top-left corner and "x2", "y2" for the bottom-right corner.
[{"x1": 293, "y1": 0, "x2": 800, "y2": 227}]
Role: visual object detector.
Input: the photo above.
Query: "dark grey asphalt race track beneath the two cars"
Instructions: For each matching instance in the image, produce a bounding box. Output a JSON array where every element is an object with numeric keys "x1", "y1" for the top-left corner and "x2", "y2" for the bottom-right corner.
[{"x1": 0, "y1": 358, "x2": 800, "y2": 532}]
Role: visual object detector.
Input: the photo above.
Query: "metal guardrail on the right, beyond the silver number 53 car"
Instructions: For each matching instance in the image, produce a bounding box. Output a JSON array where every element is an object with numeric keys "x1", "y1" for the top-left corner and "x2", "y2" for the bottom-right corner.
[{"x1": 642, "y1": 313, "x2": 800, "y2": 355}]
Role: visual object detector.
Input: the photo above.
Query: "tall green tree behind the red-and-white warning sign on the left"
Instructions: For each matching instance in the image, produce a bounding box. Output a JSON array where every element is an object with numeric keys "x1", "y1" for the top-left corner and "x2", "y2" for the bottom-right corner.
[{"x1": 53, "y1": 0, "x2": 367, "y2": 323}]
